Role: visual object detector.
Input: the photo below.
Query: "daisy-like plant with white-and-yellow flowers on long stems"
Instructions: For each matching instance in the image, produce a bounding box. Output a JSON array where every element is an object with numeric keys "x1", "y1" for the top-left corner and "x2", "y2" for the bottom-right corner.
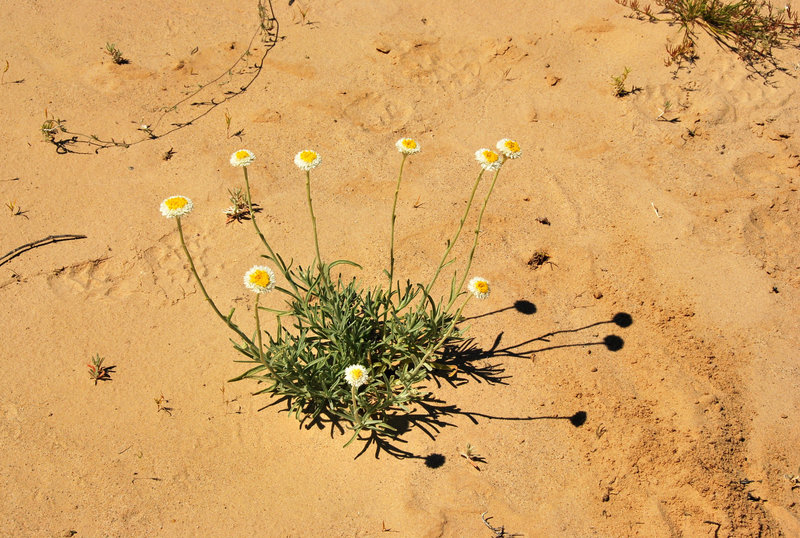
[{"x1": 161, "y1": 138, "x2": 521, "y2": 444}]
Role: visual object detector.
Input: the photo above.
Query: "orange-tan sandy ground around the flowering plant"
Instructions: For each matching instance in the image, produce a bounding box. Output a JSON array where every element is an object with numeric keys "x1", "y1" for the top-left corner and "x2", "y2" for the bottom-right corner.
[{"x1": 0, "y1": 0, "x2": 800, "y2": 537}]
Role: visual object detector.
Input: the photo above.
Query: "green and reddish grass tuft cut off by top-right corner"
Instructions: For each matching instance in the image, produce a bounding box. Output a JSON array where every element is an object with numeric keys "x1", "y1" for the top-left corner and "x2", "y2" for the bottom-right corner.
[{"x1": 615, "y1": 0, "x2": 800, "y2": 76}]
